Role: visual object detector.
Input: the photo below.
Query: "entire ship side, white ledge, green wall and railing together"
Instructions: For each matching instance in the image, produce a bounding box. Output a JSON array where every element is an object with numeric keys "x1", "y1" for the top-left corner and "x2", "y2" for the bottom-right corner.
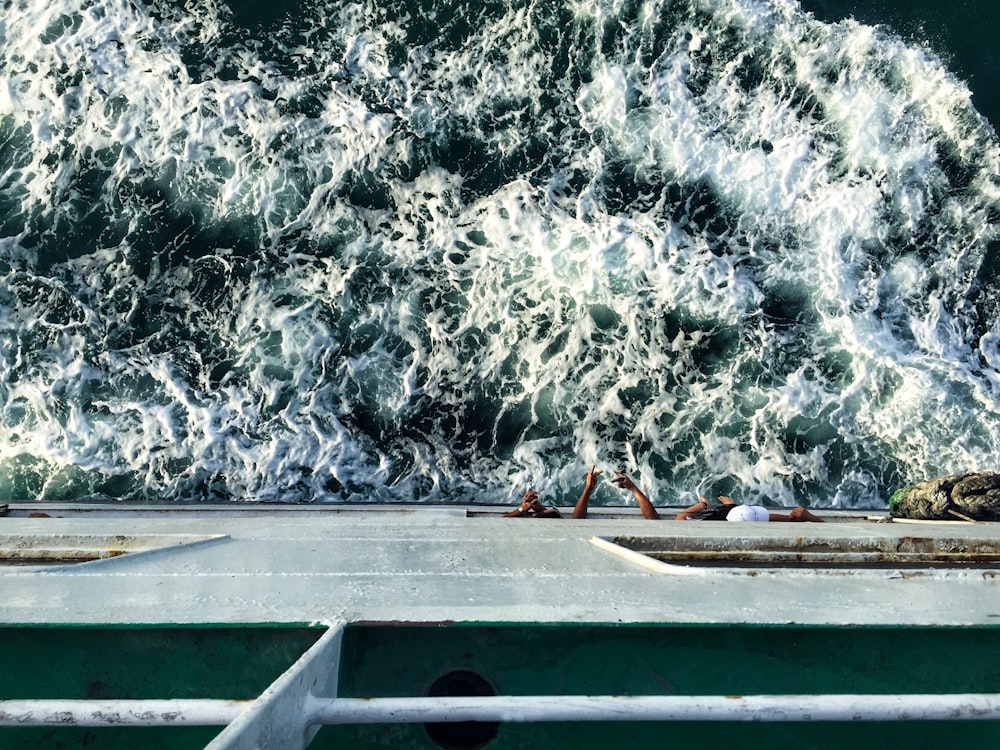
[{"x1": 0, "y1": 504, "x2": 1000, "y2": 750}]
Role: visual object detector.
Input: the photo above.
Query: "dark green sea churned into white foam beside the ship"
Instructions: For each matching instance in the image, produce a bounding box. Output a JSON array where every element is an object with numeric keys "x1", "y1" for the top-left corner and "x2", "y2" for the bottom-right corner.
[{"x1": 0, "y1": 0, "x2": 1000, "y2": 508}]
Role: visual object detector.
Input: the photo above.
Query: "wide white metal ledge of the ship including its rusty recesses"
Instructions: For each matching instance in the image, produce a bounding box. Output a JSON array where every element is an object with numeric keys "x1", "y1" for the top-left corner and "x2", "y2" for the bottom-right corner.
[{"x1": 0, "y1": 504, "x2": 1000, "y2": 626}]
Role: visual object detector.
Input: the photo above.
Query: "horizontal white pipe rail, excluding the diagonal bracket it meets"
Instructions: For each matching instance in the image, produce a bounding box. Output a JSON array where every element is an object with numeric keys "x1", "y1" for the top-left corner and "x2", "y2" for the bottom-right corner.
[{"x1": 0, "y1": 693, "x2": 1000, "y2": 727}]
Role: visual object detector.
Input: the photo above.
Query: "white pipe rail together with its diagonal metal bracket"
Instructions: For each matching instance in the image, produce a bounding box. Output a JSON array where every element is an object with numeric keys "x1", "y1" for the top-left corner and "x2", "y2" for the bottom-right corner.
[{"x1": 0, "y1": 623, "x2": 1000, "y2": 750}]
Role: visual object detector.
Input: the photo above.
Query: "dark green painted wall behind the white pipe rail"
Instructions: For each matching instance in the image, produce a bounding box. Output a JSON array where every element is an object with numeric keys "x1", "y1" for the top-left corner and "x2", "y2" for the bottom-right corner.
[{"x1": 0, "y1": 624, "x2": 1000, "y2": 750}]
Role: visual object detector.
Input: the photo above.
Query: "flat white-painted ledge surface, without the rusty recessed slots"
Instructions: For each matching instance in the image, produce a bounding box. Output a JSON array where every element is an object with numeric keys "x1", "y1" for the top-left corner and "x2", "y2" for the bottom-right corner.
[{"x1": 0, "y1": 509, "x2": 1000, "y2": 625}]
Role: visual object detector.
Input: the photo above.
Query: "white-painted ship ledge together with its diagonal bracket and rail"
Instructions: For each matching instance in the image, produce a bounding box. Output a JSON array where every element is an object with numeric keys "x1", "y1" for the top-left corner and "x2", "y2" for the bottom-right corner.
[{"x1": 0, "y1": 505, "x2": 1000, "y2": 750}]
